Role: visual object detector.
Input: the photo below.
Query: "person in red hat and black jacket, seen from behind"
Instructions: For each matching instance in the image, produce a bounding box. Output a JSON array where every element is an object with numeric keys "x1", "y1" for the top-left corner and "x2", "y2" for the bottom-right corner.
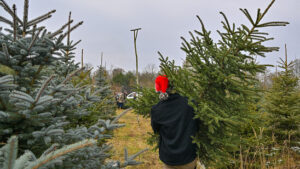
[{"x1": 151, "y1": 76, "x2": 197, "y2": 169}]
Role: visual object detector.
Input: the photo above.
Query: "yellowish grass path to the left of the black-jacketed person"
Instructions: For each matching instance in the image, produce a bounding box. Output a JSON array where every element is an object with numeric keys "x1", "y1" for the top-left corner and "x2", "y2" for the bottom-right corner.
[{"x1": 109, "y1": 110, "x2": 163, "y2": 169}]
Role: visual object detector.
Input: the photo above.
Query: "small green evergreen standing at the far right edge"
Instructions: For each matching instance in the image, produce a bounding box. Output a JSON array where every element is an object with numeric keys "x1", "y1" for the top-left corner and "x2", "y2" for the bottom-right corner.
[{"x1": 265, "y1": 56, "x2": 300, "y2": 146}]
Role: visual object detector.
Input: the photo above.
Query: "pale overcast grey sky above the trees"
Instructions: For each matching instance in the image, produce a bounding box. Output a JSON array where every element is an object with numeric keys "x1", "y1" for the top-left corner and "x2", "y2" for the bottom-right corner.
[{"x1": 0, "y1": 0, "x2": 300, "y2": 71}]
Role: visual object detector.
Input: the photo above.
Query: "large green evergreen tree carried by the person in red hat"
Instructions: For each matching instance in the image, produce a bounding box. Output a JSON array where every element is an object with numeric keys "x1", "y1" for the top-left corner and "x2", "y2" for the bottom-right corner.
[{"x1": 134, "y1": 0, "x2": 288, "y2": 168}]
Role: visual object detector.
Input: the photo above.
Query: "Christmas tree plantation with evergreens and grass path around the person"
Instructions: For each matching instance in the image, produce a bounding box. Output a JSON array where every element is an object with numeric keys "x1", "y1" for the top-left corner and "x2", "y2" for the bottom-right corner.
[{"x1": 0, "y1": 0, "x2": 300, "y2": 169}]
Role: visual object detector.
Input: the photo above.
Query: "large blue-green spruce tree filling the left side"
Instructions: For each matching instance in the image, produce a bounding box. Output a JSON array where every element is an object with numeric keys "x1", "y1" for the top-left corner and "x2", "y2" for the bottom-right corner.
[{"x1": 0, "y1": 0, "x2": 145, "y2": 169}]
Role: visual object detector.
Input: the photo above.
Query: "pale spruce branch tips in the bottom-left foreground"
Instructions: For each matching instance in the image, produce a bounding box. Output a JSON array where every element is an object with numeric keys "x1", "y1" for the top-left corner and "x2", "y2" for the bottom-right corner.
[{"x1": 0, "y1": 136, "x2": 147, "y2": 169}]
